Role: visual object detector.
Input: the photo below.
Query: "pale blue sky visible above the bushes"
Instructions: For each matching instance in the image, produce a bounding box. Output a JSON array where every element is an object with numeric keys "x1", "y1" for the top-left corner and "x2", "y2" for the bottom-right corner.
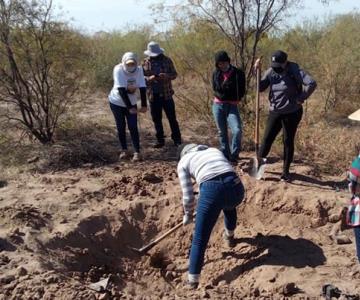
[{"x1": 53, "y1": 0, "x2": 360, "y2": 32}]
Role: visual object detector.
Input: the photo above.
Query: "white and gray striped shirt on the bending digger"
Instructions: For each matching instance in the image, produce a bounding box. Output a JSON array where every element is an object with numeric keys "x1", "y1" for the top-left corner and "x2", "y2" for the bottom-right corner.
[{"x1": 177, "y1": 145, "x2": 234, "y2": 214}]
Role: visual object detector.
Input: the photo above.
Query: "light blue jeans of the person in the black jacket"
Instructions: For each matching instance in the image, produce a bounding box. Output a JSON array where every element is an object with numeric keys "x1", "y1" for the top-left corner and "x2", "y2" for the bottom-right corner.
[{"x1": 212, "y1": 103, "x2": 242, "y2": 160}]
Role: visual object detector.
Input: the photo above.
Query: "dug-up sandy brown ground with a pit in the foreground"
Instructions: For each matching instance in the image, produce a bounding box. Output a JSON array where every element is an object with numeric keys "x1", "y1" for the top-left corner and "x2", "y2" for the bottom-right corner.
[{"x1": 0, "y1": 95, "x2": 360, "y2": 299}]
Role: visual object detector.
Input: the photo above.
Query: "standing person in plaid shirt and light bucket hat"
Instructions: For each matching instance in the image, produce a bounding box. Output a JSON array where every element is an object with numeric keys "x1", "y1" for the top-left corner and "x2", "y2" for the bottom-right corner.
[{"x1": 143, "y1": 42, "x2": 181, "y2": 148}]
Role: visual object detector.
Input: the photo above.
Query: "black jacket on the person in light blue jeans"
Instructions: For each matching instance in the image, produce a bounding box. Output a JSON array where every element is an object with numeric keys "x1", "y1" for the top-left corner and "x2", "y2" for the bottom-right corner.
[{"x1": 212, "y1": 65, "x2": 245, "y2": 101}]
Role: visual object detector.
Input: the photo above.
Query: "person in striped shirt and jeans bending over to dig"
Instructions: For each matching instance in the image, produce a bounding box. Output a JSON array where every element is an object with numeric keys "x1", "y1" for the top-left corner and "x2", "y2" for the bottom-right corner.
[{"x1": 177, "y1": 144, "x2": 244, "y2": 289}]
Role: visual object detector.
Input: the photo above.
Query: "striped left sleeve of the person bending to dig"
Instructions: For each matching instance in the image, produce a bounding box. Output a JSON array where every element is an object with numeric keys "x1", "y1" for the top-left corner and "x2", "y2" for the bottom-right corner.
[{"x1": 177, "y1": 161, "x2": 195, "y2": 215}]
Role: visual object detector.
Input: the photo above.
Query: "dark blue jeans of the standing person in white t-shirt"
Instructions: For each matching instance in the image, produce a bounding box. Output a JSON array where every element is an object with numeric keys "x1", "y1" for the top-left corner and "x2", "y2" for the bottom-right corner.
[{"x1": 109, "y1": 102, "x2": 140, "y2": 152}]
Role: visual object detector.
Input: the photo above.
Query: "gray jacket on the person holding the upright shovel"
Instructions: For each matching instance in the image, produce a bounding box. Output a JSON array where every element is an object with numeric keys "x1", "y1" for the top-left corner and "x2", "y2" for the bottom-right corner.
[{"x1": 260, "y1": 62, "x2": 316, "y2": 114}]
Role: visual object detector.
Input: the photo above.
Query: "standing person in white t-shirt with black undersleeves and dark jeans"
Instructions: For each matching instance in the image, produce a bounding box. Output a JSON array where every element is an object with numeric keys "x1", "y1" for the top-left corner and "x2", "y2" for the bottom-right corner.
[{"x1": 108, "y1": 52, "x2": 147, "y2": 161}]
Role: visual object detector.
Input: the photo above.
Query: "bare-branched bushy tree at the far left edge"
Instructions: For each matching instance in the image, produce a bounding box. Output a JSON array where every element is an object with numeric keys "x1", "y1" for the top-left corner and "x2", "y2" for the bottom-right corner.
[{"x1": 0, "y1": 0, "x2": 83, "y2": 144}]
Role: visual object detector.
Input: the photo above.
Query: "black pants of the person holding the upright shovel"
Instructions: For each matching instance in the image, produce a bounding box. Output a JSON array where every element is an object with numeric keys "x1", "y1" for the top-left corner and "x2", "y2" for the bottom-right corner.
[{"x1": 259, "y1": 108, "x2": 303, "y2": 174}]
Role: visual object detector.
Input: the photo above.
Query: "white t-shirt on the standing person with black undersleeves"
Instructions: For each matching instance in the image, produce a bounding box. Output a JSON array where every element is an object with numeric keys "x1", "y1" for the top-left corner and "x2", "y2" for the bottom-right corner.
[{"x1": 109, "y1": 64, "x2": 146, "y2": 107}]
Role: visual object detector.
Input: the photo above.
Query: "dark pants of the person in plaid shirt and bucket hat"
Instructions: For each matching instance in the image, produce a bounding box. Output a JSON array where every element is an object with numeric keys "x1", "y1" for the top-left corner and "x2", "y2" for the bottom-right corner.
[{"x1": 150, "y1": 94, "x2": 181, "y2": 144}]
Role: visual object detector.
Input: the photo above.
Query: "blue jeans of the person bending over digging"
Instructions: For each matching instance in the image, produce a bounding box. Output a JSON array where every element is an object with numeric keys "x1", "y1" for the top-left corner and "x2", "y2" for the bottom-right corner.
[{"x1": 189, "y1": 172, "x2": 244, "y2": 274}]
